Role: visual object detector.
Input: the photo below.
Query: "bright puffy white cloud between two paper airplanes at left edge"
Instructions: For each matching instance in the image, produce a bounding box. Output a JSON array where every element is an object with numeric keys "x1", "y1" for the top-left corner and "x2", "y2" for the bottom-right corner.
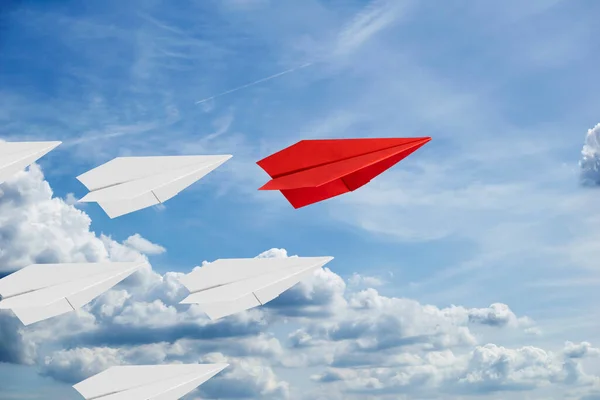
[{"x1": 0, "y1": 164, "x2": 109, "y2": 272}]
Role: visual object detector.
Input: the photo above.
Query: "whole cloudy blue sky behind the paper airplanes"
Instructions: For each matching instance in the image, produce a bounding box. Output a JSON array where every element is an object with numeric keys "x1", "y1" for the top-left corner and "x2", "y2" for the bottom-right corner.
[{"x1": 0, "y1": 0, "x2": 600, "y2": 400}]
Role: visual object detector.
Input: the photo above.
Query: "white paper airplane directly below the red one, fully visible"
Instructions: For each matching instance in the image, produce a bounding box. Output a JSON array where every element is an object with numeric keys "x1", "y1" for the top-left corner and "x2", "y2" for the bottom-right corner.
[{"x1": 179, "y1": 257, "x2": 333, "y2": 320}]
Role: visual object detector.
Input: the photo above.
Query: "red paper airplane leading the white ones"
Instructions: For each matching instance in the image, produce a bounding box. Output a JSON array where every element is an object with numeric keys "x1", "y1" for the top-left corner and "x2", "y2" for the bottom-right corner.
[{"x1": 257, "y1": 137, "x2": 431, "y2": 208}]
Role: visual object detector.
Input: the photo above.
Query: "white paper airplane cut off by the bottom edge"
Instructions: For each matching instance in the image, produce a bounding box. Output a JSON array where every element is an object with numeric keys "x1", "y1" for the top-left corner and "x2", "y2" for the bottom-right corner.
[{"x1": 73, "y1": 364, "x2": 229, "y2": 400}]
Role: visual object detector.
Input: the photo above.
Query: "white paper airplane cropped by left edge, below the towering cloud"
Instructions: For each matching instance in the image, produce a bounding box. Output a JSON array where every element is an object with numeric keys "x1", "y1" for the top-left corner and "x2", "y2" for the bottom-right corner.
[{"x1": 0, "y1": 261, "x2": 147, "y2": 325}]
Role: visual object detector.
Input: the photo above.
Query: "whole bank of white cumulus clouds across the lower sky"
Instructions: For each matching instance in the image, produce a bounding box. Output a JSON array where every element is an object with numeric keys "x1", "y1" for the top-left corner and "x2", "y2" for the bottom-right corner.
[{"x1": 0, "y1": 165, "x2": 600, "y2": 399}]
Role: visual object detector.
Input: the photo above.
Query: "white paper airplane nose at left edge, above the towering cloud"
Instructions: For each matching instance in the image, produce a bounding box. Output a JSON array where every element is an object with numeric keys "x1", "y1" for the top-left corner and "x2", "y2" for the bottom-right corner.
[{"x1": 0, "y1": 142, "x2": 62, "y2": 183}]
